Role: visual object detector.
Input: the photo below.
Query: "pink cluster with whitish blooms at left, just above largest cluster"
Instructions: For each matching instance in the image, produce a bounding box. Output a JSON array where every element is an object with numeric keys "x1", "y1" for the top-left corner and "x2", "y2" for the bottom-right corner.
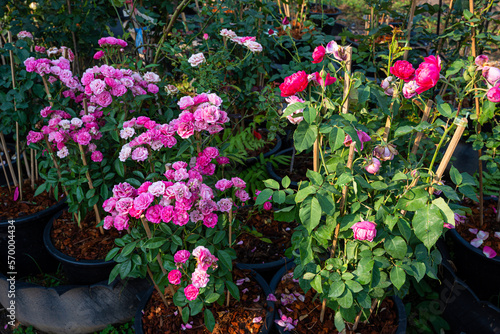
[{"x1": 119, "y1": 116, "x2": 177, "y2": 162}]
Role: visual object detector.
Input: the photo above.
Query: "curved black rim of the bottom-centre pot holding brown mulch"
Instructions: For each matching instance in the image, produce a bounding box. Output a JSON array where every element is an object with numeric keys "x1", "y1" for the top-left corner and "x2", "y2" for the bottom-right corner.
[{"x1": 134, "y1": 264, "x2": 274, "y2": 334}]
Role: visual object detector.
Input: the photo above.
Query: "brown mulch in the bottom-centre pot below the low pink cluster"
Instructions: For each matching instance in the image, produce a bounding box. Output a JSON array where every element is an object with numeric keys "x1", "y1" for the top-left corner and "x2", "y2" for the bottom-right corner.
[{"x1": 142, "y1": 269, "x2": 272, "y2": 334}]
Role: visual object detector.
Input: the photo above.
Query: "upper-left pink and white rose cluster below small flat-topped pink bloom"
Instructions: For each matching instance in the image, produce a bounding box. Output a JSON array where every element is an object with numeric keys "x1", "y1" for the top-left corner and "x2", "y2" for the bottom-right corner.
[{"x1": 81, "y1": 65, "x2": 159, "y2": 107}]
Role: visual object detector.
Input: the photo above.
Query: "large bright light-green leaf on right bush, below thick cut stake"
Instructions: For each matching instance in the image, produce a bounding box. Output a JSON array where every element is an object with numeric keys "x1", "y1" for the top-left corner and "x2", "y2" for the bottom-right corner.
[{"x1": 412, "y1": 204, "x2": 443, "y2": 250}]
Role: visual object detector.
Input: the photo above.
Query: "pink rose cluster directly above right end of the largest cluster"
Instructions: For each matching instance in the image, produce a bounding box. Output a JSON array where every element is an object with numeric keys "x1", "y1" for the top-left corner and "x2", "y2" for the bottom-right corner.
[{"x1": 170, "y1": 93, "x2": 229, "y2": 139}]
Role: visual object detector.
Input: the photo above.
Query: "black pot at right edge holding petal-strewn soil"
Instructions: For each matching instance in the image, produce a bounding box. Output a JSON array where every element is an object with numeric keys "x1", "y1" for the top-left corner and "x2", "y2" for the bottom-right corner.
[{"x1": 446, "y1": 229, "x2": 500, "y2": 300}]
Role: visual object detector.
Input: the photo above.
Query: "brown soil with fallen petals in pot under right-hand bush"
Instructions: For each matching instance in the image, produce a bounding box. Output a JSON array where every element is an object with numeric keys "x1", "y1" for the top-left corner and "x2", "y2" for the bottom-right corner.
[{"x1": 275, "y1": 270, "x2": 399, "y2": 334}]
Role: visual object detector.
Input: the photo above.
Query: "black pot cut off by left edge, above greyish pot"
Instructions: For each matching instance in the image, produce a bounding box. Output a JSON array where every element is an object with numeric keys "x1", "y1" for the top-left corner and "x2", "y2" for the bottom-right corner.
[{"x1": 0, "y1": 199, "x2": 66, "y2": 277}]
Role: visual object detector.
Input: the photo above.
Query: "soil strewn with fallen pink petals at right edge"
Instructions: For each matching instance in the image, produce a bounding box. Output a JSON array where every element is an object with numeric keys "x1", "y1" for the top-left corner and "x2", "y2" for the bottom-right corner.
[{"x1": 456, "y1": 200, "x2": 500, "y2": 255}]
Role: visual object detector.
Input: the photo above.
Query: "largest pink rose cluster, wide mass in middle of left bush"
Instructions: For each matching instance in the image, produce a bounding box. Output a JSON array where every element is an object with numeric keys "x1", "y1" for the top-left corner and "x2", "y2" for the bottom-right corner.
[{"x1": 103, "y1": 147, "x2": 248, "y2": 230}]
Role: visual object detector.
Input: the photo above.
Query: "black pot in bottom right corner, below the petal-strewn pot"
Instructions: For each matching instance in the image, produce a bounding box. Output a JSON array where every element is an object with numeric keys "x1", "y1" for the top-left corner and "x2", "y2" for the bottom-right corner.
[{"x1": 436, "y1": 240, "x2": 500, "y2": 334}]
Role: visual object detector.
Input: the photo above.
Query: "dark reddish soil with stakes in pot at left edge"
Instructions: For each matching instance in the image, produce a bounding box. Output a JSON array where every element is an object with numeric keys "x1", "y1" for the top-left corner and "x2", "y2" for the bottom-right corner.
[{"x1": 0, "y1": 180, "x2": 57, "y2": 221}]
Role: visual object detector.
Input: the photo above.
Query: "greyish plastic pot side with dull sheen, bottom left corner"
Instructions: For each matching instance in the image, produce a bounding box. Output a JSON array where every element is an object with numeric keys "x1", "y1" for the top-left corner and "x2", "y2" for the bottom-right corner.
[{"x1": 0, "y1": 274, "x2": 151, "y2": 334}]
